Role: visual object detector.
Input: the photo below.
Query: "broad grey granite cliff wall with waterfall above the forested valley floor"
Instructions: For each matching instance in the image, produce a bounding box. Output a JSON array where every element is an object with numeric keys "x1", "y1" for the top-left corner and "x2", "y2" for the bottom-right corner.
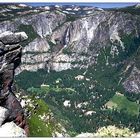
[{"x1": 0, "y1": 5, "x2": 140, "y2": 94}]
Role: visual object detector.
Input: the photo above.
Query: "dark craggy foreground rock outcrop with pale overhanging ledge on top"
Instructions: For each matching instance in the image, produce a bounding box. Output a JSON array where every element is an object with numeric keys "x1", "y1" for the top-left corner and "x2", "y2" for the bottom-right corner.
[{"x1": 0, "y1": 31, "x2": 28, "y2": 137}]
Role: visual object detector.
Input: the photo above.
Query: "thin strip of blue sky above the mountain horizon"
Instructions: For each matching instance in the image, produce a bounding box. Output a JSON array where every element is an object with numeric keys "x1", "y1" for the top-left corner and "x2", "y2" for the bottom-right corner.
[{"x1": 26, "y1": 2, "x2": 136, "y2": 8}]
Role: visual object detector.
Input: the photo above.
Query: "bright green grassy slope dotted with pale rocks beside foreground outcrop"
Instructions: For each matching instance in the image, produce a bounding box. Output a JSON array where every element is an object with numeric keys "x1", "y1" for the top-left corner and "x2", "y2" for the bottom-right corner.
[{"x1": 16, "y1": 91, "x2": 69, "y2": 137}]
